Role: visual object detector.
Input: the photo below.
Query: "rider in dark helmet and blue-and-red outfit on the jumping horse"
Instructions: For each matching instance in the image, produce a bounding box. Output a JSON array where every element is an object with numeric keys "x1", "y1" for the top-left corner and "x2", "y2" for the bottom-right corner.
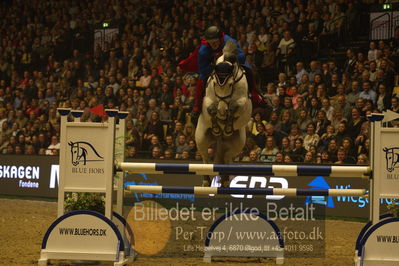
[{"x1": 179, "y1": 26, "x2": 261, "y2": 113}]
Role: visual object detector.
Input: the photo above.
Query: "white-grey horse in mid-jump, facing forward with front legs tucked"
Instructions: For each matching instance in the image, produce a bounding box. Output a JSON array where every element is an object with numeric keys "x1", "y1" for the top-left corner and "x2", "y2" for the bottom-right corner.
[{"x1": 195, "y1": 41, "x2": 252, "y2": 187}]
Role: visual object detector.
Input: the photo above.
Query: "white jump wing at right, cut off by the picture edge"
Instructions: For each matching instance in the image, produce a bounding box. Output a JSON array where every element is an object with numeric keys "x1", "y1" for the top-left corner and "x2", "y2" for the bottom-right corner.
[{"x1": 355, "y1": 111, "x2": 399, "y2": 266}]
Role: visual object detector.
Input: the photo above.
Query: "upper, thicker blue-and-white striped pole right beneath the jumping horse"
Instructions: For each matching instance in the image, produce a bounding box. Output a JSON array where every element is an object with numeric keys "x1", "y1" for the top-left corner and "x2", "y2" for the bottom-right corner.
[{"x1": 116, "y1": 162, "x2": 371, "y2": 178}]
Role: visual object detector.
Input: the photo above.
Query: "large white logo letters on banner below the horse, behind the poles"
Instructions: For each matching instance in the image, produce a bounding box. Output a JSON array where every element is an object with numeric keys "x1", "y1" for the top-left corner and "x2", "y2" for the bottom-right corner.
[{"x1": 211, "y1": 175, "x2": 288, "y2": 200}]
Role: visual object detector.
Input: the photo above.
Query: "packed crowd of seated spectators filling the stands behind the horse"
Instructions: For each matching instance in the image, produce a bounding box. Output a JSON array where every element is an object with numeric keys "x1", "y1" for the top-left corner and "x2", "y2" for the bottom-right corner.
[{"x1": 0, "y1": 0, "x2": 399, "y2": 164}]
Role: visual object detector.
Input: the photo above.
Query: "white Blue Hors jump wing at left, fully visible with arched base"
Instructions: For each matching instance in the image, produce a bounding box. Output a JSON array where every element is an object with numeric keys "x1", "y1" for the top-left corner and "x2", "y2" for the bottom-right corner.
[{"x1": 38, "y1": 109, "x2": 134, "y2": 266}]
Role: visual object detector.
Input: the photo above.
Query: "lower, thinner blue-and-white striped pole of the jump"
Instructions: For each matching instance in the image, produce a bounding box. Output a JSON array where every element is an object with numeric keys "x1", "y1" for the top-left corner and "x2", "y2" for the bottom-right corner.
[{"x1": 127, "y1": 185, "x2": 367, "y2": 197}]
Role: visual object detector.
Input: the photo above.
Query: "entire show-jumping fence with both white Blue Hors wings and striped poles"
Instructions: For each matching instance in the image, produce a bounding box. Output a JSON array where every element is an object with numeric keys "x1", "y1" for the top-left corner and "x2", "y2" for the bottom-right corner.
[{"x1": 39, "y1": 109, "x2": 399, "y2": 265}]
